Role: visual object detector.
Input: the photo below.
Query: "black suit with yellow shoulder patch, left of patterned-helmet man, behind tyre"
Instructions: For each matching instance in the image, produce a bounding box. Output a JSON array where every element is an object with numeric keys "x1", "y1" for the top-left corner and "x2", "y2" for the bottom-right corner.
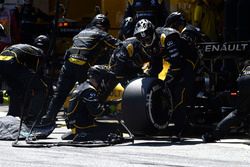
[{"x1": 105, "y1": 37, "x2": 162, "y2": 96}]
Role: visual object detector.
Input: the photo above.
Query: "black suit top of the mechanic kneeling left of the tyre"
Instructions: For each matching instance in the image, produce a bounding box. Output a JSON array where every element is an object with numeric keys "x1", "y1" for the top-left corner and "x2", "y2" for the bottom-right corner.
[{"x1": 66, "y1": 81, "x2": 104, "y2": 131}]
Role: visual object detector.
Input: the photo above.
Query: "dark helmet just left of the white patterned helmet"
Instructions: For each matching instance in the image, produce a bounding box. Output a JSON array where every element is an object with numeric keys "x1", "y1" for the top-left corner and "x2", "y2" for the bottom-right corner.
[{"x1": 121, "y1": 17, "x2": 135, "y2": 38}]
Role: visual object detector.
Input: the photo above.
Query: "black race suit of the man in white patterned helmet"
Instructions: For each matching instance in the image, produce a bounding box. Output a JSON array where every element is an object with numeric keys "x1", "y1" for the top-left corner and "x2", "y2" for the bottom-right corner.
[{"x1": 155, "y1": 28, "x2": 198, "y2": 135}]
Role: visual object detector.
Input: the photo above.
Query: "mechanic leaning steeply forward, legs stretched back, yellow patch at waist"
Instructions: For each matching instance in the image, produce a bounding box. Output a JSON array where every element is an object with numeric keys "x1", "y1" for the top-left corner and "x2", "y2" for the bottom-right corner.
[{"x1": 41, "y1": 14, "x2": 118, "y2": 124}]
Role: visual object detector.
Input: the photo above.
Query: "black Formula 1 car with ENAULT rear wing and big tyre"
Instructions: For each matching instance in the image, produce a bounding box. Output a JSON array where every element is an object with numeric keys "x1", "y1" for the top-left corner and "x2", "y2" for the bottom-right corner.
[{"x1": 115, "y1": 41, "x2": 250, "y2": 135}]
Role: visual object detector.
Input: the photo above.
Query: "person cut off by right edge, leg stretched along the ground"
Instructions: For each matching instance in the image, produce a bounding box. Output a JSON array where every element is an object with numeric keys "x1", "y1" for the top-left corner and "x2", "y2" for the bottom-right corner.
[{"x1": 202, "y1": 61, "x2": 250, "y2": 143}]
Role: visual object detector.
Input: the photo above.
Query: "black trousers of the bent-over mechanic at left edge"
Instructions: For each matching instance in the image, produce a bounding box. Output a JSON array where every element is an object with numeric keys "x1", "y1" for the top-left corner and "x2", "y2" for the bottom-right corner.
[{"x1": 0, "y1": 59, "x2": 48, "y2": 119}]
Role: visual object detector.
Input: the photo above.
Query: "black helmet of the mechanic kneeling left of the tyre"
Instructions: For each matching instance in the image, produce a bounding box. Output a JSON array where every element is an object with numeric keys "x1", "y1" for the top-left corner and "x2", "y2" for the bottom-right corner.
[{"x1": 87, "y1": 65, "x2": 114, "y2": 90}]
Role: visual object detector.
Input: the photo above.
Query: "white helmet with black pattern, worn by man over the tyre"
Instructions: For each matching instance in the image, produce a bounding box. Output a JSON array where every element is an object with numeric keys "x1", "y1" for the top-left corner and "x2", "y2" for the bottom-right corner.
[{"x1": 134, "y1": 19, "x2": 155, "y2": 47}]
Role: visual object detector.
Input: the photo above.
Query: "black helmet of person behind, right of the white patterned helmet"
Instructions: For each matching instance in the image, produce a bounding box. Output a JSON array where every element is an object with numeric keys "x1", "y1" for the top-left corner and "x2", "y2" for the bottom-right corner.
[{"x1": 164, "y1": 12, "x2": 186, "y2": 29}]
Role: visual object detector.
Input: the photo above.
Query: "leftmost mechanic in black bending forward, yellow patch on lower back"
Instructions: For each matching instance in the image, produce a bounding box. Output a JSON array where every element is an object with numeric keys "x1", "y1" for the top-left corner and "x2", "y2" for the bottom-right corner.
[{"x1": 0, "y1": 35, "x2": 49, "y2": 123}]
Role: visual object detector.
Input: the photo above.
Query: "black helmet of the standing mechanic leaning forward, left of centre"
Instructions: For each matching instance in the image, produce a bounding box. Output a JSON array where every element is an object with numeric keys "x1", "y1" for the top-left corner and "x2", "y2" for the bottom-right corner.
[{"x1": 91, "y1": 14, "x2": 110, "y2": 30}]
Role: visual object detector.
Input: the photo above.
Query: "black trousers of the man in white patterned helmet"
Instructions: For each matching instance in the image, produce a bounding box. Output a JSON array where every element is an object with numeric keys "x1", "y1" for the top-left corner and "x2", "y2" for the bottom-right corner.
[{"x1": 165, "y1": 64, "x2": 195, "y2": 136}]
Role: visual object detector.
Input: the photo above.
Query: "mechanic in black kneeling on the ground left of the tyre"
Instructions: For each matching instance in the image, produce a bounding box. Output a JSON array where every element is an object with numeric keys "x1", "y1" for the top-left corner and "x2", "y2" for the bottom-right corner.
[{"x1": 62, "y1": 65, "x2": 115, "y2": 141}]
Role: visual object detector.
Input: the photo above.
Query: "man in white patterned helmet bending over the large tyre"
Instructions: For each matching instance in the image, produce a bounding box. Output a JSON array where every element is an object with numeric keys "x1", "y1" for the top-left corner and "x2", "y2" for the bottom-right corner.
[{"x1": 134, "y1": 19, "x2": 198, "y2": 142}]
